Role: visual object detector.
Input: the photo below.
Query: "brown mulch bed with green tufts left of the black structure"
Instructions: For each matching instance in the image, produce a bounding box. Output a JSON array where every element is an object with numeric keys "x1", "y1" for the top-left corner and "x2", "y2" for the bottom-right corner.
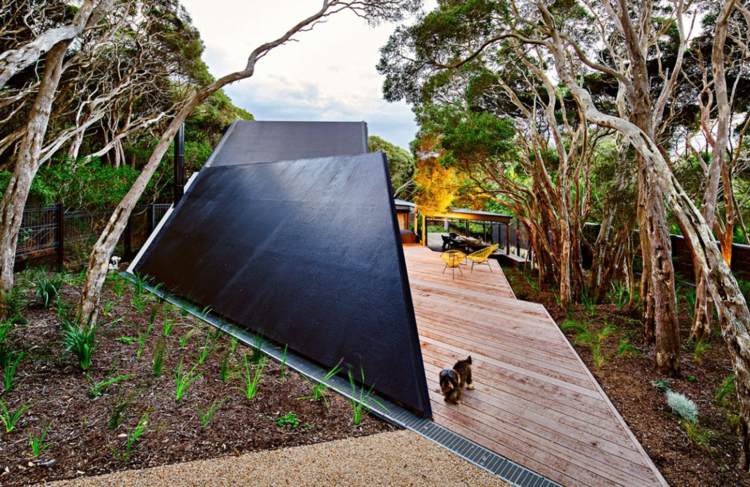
[{"x1": 0, "y1": 272, "x2": 393, "y2": 485}]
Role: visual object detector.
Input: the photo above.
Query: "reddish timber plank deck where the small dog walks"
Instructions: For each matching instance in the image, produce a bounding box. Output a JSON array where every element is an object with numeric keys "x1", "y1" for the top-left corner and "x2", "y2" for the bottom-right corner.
[{"x1": 404, "y1": 246, "x2": 666, "y2": 486}]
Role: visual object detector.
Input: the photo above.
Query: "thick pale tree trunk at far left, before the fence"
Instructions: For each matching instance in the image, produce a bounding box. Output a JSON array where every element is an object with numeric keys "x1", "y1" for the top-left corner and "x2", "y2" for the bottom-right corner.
[{"x1": 0, "y1": 41, "x2": 70, "y2": 296}]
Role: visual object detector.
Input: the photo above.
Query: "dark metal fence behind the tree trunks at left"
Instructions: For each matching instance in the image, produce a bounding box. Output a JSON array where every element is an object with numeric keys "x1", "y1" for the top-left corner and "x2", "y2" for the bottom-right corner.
[{"x1": 16, "y1": 203, "x2": 171, "y2": 269}]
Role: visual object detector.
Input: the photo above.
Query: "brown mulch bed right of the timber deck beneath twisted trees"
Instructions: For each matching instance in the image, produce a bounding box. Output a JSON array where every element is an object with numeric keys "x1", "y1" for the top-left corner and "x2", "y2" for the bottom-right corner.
[{"x1": 503, "y1": 266, "x2": 750, "y2": 486}]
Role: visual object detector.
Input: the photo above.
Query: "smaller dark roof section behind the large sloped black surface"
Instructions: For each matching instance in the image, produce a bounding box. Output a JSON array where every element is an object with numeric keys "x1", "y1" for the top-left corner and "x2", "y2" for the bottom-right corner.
[{"x1": 206, "y1": 120, "x2": 367, "y2": 167}]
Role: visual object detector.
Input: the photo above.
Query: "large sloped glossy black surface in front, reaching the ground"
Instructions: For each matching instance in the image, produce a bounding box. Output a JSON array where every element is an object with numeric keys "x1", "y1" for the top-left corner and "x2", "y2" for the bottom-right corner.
[{"x1": 135, "y1": 153, "x2": 430, "y2": 416}]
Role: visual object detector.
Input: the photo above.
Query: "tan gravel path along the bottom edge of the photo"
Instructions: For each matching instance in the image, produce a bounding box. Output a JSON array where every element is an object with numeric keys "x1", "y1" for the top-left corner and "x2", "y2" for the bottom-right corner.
[{"x1": 45, "y1": 431, "x2": 507, "y2": 487}]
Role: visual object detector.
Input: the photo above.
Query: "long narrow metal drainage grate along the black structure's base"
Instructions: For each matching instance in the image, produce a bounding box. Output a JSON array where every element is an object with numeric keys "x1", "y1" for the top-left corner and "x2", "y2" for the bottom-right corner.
[{"x1": 128, "y1": 272, "x2": 560, "y2": 487}]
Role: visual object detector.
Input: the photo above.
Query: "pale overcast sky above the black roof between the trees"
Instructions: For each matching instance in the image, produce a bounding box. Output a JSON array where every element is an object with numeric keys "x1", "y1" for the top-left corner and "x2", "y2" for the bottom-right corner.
[{"x1": 182, "y1": 0, "x2": 416, "y2": 148}]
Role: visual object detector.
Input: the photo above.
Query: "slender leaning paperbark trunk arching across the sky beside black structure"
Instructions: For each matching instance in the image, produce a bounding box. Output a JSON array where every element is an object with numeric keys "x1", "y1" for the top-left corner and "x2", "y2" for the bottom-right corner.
[{"x1": 77, "y1": 0, "x2": 419, "y2": 326}]
